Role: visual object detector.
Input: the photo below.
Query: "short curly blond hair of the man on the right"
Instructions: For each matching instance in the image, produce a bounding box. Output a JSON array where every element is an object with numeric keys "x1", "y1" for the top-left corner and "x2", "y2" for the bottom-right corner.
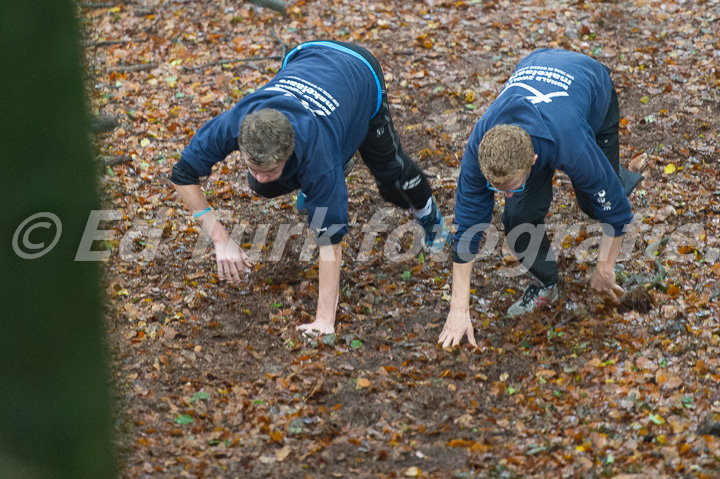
[{"x1": 478, "y1": 125, "x2": 535, "y2": 185}]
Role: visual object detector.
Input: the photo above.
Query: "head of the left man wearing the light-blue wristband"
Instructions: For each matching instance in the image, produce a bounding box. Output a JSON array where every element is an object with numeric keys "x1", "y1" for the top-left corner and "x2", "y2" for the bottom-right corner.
[{"x1": 238, "y1": 108, "x2": 295, "y2": 183}]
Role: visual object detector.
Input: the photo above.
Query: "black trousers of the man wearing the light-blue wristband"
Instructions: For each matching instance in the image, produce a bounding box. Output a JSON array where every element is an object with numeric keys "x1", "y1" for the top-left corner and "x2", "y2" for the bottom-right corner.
[{"x1": 248, "y1": 41, "x2": 432, "y2": 209}]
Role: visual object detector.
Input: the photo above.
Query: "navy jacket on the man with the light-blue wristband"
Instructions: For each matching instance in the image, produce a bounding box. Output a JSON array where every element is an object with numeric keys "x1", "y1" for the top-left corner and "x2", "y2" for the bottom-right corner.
[{"x1": 181, "y1": 42, "x2": 381, "y2": 244}]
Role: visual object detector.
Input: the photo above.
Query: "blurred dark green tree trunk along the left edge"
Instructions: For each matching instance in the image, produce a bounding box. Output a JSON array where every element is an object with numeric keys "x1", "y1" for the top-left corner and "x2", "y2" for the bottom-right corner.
[{"x1": 0, "y1": 0, "x2": 115, "y2": 479}]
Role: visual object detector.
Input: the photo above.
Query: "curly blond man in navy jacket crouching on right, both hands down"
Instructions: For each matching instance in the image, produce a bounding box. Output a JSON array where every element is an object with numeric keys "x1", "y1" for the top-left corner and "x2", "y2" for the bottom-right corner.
[{"x1": 439, "y1": 50, "x2": 642, "y2": 347}]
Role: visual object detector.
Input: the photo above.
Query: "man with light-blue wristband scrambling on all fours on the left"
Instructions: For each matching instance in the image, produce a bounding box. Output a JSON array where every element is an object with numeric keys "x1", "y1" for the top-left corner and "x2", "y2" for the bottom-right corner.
[{"x1": 171, "y1": 41, "x2": 449, "y2": 333}]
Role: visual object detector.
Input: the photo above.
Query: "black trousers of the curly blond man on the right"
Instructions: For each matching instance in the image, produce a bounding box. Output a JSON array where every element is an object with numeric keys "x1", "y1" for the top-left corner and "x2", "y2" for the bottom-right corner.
[{"x1": 502, "y1": 87, "x2": 620, "y2": 286}]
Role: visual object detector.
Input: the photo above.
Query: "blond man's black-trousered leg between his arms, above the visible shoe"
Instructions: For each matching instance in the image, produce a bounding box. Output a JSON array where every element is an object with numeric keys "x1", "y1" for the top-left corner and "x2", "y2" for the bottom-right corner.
[{"x1": 502, "y1": 170, "x2": 558, "y2": 286}]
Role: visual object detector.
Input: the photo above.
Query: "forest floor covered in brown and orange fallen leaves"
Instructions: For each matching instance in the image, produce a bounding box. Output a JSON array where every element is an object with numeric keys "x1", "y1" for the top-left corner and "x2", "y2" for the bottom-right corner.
[{"x1": 80, "y1": 0, "x2": 720, "y2": 479}]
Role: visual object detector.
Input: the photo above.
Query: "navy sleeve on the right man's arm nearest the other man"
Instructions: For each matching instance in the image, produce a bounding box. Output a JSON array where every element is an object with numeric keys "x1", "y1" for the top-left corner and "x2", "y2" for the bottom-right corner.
[{"x1": 453, "y1": 134, "x2": 495, "y2": 263}]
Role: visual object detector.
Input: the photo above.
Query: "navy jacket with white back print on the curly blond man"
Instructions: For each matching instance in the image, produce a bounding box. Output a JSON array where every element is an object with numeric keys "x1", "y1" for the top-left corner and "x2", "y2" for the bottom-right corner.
[{"x1": 453, "y1": 49, "x2": 632, "y2": 261}]
